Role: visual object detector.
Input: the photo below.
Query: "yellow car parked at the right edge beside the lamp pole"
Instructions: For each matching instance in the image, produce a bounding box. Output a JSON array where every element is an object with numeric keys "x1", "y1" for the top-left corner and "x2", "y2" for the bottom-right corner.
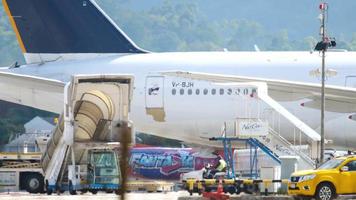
[{"x1": 288, "y1": 155, "x2": 356, "y2": 200}]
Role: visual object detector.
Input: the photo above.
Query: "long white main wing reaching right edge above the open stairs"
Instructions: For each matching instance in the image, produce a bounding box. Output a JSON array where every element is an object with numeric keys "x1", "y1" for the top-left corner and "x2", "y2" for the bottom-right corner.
[{"x1": 162, "y1": 71, "x2": 356, "y2": 113}]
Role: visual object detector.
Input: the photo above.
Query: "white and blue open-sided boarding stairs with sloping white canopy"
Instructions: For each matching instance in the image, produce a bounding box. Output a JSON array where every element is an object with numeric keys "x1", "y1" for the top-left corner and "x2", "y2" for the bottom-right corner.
[{"x1": 218, "y1": 82, "x2": 320, "y2": 176}]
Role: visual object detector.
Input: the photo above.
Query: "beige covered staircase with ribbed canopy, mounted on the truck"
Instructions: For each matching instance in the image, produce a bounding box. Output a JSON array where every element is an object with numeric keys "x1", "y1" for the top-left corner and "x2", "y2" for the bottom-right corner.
[{"x1": 41, "y1": 75, "x2": 133, "y2": 193}]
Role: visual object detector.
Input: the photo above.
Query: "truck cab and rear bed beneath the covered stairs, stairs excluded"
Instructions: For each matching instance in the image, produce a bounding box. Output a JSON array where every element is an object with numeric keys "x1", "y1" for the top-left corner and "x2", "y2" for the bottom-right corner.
[{"x1": 0, "y1": 148, "x2": 121, "y2": 194}]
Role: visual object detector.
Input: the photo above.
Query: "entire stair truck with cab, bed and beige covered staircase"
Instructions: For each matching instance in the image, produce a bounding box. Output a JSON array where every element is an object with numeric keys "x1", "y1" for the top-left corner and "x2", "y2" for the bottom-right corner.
[{"x1": 0, "y1": 74, "x2": 133, "y2": 195}]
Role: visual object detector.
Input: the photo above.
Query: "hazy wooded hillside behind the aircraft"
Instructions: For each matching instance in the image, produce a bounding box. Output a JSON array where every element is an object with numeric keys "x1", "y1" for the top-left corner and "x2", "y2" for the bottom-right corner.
[{"x1": 0, "y1": 0, "x2": 356, "y2": 66}]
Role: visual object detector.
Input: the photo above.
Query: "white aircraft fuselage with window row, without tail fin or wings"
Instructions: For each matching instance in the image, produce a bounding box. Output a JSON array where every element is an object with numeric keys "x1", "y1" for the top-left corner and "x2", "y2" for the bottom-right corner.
[{"x1": 8, "y1": 52, "x2": 356, "y2": 149}]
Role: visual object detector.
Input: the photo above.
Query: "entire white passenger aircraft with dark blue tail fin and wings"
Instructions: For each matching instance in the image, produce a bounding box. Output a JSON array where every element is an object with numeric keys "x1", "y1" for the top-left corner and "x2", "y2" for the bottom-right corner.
[{"x1": 0, "y1": 0, "x2": 356, "y2": 149}]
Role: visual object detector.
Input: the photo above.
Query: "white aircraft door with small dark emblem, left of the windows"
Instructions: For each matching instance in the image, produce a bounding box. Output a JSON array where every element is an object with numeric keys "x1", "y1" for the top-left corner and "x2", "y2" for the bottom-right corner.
[{"x1": 145, "y1": 76, "x2": 164, "y2": 108}]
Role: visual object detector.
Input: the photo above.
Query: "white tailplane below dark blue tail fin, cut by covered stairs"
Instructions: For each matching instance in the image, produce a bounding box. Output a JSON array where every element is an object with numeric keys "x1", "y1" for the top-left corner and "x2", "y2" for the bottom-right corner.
[{"x1": 0, "y1": 72, "x2": 65, "y2": 113}]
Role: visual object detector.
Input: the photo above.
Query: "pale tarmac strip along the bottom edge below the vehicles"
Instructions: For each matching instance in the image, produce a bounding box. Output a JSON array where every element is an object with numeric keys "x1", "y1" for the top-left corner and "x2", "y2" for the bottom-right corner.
[{"x1": 0, "y1": 191, "x2": 356, "y2": 200}]
